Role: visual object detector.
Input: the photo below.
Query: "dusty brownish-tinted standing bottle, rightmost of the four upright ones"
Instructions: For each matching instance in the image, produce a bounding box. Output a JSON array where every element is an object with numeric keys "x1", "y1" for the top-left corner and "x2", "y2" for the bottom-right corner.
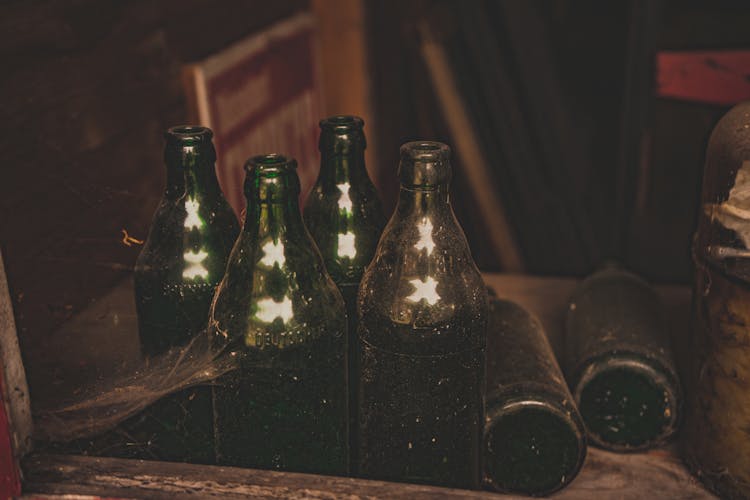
[{"x1": 357, "y1": 142, "x2": 487, "y2": 488}]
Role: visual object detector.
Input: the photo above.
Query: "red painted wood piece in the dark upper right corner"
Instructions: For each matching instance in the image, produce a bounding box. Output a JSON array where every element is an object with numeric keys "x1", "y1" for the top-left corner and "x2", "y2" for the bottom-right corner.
[{"x1": 656, "y1": 50, "x2": 750, "y2": 106}]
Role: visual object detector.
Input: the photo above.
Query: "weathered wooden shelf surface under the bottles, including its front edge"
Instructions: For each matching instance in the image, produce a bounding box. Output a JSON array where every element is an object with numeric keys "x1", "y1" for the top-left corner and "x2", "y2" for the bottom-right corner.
[{"x1": 24, "y1": 274, "x2": 713, "y2": 500}]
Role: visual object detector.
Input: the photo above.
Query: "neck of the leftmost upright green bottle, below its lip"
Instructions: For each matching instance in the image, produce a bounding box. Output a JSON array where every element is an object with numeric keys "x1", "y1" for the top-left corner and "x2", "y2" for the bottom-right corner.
[{"x1": 164, "y1": 143, "x2": 221, "y2": 198}]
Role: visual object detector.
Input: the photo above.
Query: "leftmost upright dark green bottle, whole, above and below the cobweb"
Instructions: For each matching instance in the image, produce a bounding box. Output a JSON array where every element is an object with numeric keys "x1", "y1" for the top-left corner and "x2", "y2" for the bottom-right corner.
[{"x1": 131, "y1": 126, "x2": 239, "y2": 463}]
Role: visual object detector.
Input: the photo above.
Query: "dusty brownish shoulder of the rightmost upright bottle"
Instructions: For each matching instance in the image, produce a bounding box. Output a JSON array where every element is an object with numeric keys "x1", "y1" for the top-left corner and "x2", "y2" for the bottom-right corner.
[{"x1": 358, "y1": 213, "x2": 488, "y2": 352}]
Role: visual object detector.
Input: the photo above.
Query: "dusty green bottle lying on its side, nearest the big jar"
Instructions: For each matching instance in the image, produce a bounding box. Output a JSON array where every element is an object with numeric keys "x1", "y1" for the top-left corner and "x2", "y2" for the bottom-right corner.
[{"x1": 564, "y1": 262, "x2": 682, "y2": 451}]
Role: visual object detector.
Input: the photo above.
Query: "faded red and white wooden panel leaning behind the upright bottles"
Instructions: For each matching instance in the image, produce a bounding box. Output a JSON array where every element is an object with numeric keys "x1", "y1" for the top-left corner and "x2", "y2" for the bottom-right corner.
[{"x1": 183, "y1": 12, "x2": 321, "y2": 213}]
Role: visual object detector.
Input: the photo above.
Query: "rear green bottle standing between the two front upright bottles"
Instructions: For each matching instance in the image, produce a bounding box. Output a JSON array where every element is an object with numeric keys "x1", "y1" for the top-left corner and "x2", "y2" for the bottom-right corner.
[{"x1": 304, "y1": 116, "x2": 386, "y2": 472}]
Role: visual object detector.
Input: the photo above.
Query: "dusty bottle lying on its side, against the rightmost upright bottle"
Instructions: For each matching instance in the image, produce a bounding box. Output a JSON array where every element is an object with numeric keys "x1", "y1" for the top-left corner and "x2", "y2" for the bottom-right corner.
[{"x1": 482, "y1": 297, "x2": 586, "y2": 496}]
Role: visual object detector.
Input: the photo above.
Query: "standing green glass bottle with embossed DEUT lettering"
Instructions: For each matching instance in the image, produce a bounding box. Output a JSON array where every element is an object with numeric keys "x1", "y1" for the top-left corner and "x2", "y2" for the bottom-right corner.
[{"x1": 210, "y1": 155, "x2": 348, "y2": 475}]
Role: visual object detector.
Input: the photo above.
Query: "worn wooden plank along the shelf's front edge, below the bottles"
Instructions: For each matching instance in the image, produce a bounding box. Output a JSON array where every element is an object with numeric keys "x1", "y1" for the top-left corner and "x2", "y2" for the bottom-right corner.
[{"x1": 24, "y1": 455, "x2": 512, "y2": 500}]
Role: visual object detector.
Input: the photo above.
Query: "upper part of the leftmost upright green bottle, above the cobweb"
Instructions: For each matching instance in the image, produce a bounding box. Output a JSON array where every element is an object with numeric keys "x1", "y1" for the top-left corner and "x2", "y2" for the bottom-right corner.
[{"x1": 135, "y1": 126, "x2": 239, "y2": 356}]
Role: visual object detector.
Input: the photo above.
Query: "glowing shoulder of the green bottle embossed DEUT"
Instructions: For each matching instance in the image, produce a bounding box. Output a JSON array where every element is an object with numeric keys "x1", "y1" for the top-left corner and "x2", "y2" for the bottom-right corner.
[{"x1": 211, "y1": 229, "x2": 346, "y2": 349}]
